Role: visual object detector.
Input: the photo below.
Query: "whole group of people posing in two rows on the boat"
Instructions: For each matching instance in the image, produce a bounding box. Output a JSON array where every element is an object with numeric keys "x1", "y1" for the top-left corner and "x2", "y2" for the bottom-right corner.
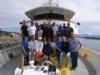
[{"x1": 21, "y1": 21, "x2": 81, "y2": 69}]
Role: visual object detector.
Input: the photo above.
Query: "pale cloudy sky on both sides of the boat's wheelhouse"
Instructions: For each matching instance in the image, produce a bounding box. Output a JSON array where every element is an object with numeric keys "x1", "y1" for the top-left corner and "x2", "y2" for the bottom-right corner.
[{"x1": 0, "y1": 0, "x2": 100, "y2": 34}]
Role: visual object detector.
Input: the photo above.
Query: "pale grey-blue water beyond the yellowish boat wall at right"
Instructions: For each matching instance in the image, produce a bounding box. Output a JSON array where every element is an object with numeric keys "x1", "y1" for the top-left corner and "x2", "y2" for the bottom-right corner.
[{"x1": 79, "y1": 38, "x2": 100, "y2": 52}]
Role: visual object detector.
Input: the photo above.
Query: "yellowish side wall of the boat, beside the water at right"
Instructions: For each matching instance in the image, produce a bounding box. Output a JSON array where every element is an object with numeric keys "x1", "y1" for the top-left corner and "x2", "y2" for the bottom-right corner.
[{"x1": 79, "y1": 48, "x2": 100, "y2": 75}]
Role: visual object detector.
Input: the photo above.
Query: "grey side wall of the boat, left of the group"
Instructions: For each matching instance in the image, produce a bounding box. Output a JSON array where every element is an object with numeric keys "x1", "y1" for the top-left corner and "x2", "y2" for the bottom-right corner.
[{"x1": 0, "y1": 44, "x2": 21, "y2": 68}]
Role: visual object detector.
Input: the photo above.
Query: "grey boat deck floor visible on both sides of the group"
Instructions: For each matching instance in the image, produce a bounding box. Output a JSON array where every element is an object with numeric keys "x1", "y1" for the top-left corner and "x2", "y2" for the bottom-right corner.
[{"x1": 0, "y1": 57, "x2": 89, "y2": 75}]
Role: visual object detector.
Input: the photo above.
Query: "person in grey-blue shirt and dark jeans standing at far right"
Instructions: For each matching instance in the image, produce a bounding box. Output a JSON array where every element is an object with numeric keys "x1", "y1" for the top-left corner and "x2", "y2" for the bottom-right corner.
[{"x1": 70, "y1": 34, "x2": 81, "y2": 69}]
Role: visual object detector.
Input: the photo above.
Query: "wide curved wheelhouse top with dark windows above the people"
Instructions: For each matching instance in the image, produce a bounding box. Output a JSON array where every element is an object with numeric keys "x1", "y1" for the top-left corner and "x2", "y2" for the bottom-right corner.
[{"x1": 25, "y1": 7, "x2": 75, "y2": 21}]
